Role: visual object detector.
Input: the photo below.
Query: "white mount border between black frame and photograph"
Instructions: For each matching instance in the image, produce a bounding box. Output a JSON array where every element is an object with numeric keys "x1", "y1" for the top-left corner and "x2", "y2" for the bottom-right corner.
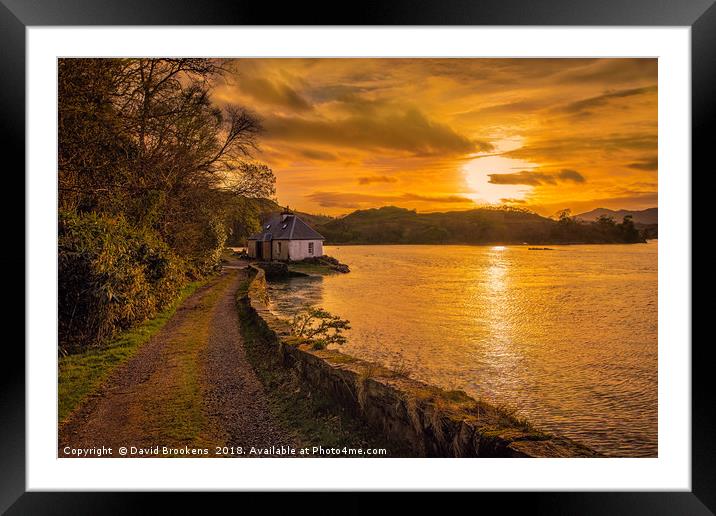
[{"x1": 26, "y1": 27, "x2": 691, "y2": 491}]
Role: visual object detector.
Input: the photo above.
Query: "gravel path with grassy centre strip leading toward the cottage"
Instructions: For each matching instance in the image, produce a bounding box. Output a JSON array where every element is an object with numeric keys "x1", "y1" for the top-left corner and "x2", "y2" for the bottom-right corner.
[{"x1": 58, "y1": 267, "x2": 293, "y2": 457}]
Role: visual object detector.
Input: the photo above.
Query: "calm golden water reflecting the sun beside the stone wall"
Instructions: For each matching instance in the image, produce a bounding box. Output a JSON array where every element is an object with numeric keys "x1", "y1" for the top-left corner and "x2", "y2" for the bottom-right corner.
[{"x1": 271, "y1": 241, "x2": 658, "y2": 456}]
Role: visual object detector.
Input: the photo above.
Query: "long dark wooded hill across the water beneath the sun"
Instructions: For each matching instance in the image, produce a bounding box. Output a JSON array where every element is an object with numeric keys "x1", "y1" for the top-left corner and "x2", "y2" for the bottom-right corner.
[{"x1": 314, "y1": 206, "x2": 643, "y2": 244}]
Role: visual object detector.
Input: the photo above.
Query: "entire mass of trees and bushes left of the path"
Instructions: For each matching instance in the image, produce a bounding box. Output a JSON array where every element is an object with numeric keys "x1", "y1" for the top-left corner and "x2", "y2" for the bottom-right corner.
[{"x1": 58, "y1": 59, "x2": 275, "y2": 353}]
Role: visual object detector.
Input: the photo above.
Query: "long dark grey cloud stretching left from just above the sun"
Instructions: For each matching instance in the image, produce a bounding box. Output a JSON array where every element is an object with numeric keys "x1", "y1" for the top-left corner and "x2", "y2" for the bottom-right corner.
[{"x1": 264, "y1": 109, "x2": 493, "y2": 155}]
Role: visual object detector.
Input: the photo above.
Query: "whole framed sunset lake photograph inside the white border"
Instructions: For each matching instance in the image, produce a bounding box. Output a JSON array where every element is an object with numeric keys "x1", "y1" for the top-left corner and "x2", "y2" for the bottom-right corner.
[{"x1": 58, "y1": 56, "x2": 656, "y2": 460}]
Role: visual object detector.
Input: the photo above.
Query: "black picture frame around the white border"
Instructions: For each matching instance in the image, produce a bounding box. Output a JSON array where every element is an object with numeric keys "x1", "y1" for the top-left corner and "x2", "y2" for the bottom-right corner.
[{"x1": 0, "y1": 0, "x2": 716, "y2": 515}]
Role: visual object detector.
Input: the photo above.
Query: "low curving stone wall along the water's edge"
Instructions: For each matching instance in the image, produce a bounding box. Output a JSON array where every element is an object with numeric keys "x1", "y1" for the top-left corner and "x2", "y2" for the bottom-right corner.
[{"x1": 241, "y1": 266, "x2": 598, "y2": 457}]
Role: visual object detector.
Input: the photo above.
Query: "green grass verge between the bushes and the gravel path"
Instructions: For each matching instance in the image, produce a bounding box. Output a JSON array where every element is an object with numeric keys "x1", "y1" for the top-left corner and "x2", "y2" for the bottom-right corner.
[{"x1": 57, "y1": 281, "x2": 204, "y2": 422}]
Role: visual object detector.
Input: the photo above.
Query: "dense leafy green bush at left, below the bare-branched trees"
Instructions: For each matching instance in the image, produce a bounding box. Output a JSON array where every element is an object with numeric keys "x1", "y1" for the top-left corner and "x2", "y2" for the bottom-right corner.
[{"x1": 58, "y1": 212, "x2": 186, "y2": 353}]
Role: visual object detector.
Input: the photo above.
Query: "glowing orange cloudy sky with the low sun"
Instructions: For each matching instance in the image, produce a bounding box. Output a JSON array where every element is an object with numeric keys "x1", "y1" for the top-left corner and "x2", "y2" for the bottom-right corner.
[{"x1": 214, "y1": 58, "x2": 658, "y2": 216}]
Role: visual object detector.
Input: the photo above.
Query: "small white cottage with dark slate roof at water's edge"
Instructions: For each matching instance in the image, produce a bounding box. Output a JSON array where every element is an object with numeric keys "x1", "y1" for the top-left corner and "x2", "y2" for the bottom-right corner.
[{"x1": 246, "y1": 210, "x2": 325, "y2": 261}]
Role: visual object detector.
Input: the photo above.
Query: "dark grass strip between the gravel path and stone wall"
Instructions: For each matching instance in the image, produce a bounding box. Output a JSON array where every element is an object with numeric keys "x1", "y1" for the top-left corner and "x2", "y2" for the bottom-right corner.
[{"x1": 237, "y1": 281, "x2": 415, "y2": 457}]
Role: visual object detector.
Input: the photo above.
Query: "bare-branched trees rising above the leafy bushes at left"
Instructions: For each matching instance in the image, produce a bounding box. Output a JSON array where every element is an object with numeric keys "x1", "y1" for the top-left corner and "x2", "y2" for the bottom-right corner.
[{"x1": 59, "y1": 58, "x2": 275, "y2": 270}]
